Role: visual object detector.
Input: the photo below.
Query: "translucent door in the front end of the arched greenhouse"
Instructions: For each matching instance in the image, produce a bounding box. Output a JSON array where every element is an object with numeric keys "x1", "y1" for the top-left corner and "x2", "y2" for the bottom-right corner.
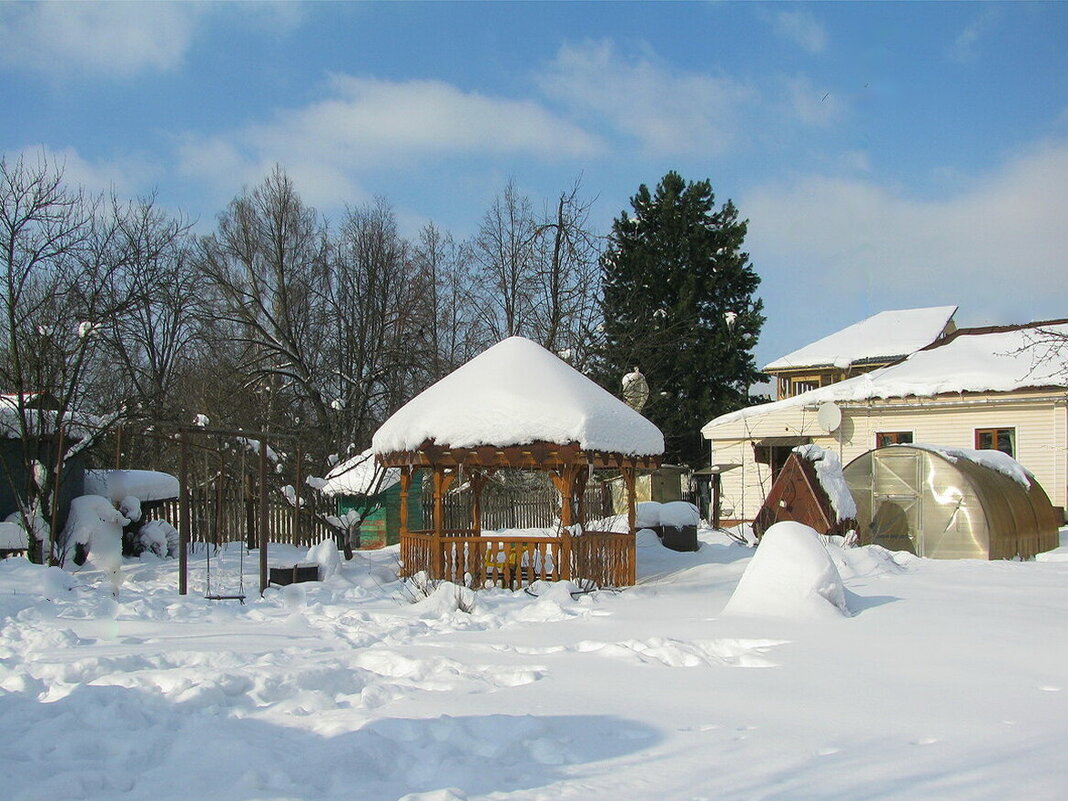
[{"x1": 871, "y1": 447, "x2": 924, "y2": 556}]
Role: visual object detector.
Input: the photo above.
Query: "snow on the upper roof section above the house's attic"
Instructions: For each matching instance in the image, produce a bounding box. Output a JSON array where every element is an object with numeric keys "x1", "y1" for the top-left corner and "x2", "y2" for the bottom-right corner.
[{"x1": 764, "y1": 305, "x2": 957, "y2": 371}]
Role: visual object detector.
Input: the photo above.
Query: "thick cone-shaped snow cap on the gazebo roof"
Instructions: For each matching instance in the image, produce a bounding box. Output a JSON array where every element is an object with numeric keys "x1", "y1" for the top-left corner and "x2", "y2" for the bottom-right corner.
[{"x1": 372, "y1": 336, "x2": 664, "y2": 456}]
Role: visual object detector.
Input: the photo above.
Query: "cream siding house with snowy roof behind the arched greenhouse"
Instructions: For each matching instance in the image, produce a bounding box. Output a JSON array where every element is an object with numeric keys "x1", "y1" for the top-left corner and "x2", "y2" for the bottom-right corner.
[{"x1": 702, "y1": 320, "x2": 1068, "y2": 521}]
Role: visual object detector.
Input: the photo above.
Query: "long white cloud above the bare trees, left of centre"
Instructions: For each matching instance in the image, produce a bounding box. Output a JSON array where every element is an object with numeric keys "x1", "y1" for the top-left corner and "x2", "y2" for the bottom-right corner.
[{"x1": 178, "y1": 75, "x2": 603, "y2": 205}]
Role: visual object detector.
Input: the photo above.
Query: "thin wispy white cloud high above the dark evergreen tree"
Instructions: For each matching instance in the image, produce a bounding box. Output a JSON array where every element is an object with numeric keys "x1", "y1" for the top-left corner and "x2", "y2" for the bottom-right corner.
[{"x1": 537, "y1": 41, "x2": 757, "y2": 155}]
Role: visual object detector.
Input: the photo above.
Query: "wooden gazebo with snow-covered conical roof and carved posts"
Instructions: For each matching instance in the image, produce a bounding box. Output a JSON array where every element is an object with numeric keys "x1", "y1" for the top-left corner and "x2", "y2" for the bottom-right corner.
[{"x1": 373, "y1": 336, "x2": 663, "y2": 587}]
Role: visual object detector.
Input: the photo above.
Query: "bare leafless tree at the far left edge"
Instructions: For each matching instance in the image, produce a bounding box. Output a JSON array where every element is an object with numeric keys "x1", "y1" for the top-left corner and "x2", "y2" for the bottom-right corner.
[{"x1": 0, "y1": 157, "x2": 140, "y2": 556}]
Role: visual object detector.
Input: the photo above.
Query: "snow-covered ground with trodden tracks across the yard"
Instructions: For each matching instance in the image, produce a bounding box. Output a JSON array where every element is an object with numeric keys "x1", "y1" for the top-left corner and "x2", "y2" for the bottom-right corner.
[{"x1": 0, "y1": 531, "x2": 1068, "y2": 801}]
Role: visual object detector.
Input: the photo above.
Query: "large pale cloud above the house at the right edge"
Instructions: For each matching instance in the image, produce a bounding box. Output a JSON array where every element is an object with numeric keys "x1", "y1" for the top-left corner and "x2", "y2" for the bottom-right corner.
[{"x1": 739, "y1": 140, "x2": 1068, "y2": 319}]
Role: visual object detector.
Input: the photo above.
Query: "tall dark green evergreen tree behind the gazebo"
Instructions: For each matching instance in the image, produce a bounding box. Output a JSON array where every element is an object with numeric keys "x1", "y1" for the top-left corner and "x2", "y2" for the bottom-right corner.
[{"x1": 598, "y1": 172, "x2": 764, "y2": 467}]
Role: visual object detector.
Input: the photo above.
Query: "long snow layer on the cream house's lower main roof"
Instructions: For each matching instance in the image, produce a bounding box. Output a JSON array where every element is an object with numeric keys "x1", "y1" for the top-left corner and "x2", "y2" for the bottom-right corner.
[{"x1": 702, "y1": 320, "x2": 1068, "y2": 437}]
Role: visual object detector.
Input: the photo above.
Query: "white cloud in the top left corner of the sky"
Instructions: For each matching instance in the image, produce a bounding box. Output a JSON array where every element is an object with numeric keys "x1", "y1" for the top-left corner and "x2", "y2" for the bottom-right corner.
[{"x1": 0, "y1": 2, "x2": 203, "y2": 77}]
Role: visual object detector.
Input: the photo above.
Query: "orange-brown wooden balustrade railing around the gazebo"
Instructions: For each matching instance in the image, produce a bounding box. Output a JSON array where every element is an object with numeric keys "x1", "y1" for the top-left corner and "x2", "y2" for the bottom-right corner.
[{"x1": 401, "y1": 530, "x2": 637, "y2": 588}]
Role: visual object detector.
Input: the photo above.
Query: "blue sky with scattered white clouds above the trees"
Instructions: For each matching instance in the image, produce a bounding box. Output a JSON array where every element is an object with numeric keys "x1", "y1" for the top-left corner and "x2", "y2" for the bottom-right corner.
[{"x1": 0, "y1": 2, "x2": 1068, "y2": 365}]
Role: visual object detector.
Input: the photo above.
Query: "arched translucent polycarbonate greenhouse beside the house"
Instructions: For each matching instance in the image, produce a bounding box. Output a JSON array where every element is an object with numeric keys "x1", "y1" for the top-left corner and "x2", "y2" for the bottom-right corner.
[{"x1": 845, "y1": 445, "x2": 1058, "y2": 559}]
